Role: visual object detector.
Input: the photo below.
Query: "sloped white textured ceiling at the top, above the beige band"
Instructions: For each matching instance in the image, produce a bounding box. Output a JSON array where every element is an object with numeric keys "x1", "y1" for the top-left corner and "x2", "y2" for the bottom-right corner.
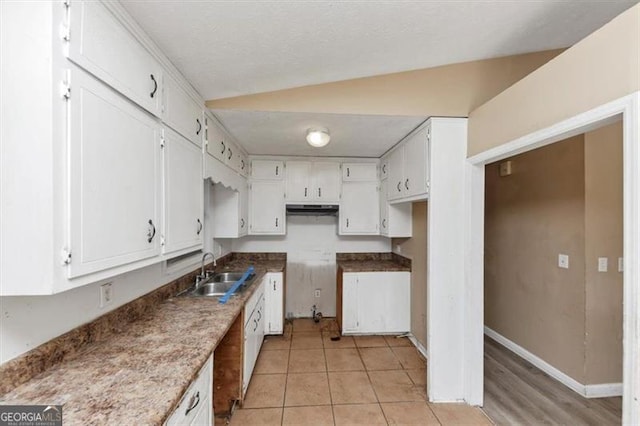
[{"x1": 121, "y1": 0, "x2": 638, "y2": 99}]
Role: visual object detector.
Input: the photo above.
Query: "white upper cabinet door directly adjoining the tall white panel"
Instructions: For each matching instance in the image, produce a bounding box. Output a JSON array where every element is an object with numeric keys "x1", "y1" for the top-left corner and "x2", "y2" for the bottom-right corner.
[{"x1": 402, "y1": 128, "x2": 429, "y2": 197}]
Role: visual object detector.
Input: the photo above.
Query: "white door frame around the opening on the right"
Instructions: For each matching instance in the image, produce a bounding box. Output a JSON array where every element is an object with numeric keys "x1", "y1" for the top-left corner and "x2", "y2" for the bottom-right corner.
[{"x1": 464, "y1": 92, "x2": 640, "y2": 425}]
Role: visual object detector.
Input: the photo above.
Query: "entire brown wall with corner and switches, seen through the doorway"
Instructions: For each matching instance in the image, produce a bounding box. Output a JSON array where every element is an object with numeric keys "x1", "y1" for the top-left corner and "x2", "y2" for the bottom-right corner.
[{"x1": 485, "y1": 123, "x2": 622, "y2": 384}]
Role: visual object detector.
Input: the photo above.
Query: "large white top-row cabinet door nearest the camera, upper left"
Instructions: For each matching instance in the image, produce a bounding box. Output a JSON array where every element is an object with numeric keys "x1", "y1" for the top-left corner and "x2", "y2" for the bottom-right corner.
[{"x1": 69, "y1": 0, "x2": 163, "y2": 116}]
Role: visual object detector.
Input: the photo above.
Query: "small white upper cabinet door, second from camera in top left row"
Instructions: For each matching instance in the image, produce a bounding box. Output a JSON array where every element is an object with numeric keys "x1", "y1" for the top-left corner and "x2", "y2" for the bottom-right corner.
[{"x1": 162, "y1": 75, "x2": 205, "y2": 146}]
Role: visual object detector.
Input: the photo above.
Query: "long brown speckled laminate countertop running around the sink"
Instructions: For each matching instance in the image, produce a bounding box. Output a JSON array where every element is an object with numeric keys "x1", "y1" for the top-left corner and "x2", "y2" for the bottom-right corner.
[{"x1": 0, "y1": 259, "x2": 286, "y2": 425}]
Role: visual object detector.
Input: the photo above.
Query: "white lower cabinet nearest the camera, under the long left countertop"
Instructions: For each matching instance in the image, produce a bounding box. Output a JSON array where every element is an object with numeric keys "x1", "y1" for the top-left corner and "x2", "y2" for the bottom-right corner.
[{"x1": 164, "y1": 355, "x2": 214, "y2": 426}]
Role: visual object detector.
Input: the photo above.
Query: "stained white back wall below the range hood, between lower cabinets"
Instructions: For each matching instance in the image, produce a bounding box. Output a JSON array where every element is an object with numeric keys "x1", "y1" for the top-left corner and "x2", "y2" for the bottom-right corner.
[{"x1": 233, "y1": 216, "x2": 391, "y2": 317}]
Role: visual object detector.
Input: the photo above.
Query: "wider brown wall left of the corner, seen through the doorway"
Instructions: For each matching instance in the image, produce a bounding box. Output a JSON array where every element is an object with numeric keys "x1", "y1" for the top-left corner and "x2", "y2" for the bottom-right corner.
[{"x1": 485, "y1": 136, "x2": 585, "y2": 383}]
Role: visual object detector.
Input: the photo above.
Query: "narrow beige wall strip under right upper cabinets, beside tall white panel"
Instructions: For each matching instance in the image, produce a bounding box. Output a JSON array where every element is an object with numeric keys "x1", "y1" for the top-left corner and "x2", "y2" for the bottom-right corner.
[{"x1": 391, "y1": 201, "x2": 428, "y2": 348}]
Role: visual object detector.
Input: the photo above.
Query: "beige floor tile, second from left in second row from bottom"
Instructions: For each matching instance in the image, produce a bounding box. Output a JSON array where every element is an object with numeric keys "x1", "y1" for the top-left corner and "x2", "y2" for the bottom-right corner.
[{"x1": 284, "y1": 373, "x2": 331, "y2": 407}]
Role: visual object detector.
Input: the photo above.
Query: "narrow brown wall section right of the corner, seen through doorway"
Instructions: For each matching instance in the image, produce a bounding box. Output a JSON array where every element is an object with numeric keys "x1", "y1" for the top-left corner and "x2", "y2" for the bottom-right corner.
[{"x1": 584, "y1": 122, "x2": 623, "y2": 384}]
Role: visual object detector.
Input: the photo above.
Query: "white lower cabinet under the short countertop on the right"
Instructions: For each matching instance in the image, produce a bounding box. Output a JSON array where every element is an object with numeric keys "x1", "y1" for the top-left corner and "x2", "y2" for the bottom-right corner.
[{"x1": 342, "y1": 272, "x2": 411, "y2": 334}]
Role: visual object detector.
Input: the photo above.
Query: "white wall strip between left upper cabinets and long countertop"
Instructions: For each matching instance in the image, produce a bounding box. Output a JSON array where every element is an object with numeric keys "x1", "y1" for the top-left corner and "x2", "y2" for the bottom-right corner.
[{"x1": 0, "y1": 258, "x2": 202, "y2": 364}]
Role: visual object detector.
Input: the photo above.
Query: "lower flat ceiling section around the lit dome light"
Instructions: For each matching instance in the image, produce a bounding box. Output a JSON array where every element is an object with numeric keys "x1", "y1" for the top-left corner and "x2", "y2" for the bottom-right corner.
[{"x1": 213, "y1": 110, "x2": 425, "y2": 158}]
